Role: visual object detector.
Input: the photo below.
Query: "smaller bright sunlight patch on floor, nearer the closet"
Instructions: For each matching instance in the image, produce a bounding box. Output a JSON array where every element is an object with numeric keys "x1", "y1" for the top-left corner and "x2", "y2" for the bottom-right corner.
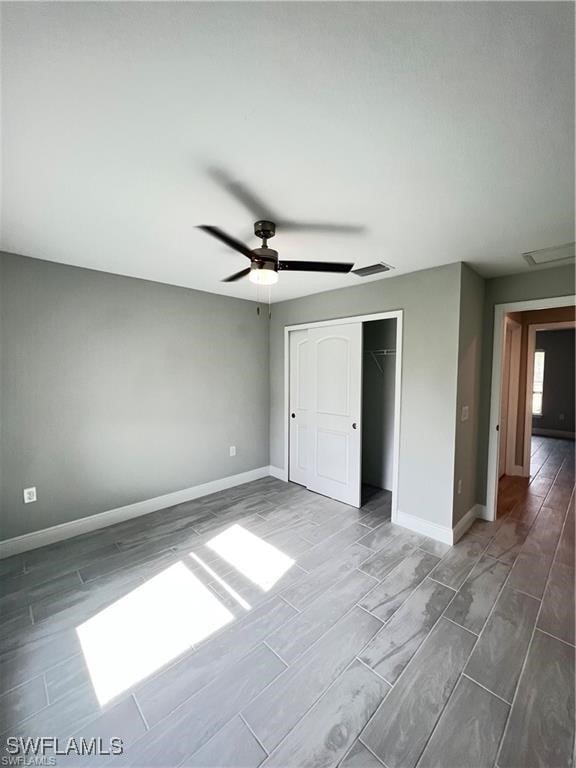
[{"x1": 206, "y1": 525, "x2": 294, "y2": 592}]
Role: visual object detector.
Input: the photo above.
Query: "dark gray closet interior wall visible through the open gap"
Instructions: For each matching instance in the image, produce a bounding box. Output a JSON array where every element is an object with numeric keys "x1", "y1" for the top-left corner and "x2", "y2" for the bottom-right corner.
[{"x1": 362, "y1": 320, "x2": 396, "y2": 491}]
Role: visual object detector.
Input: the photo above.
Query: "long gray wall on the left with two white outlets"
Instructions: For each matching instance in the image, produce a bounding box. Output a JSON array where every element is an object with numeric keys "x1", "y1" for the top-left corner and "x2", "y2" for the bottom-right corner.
[{"x1": 0, "y1": 254, "x2": 269, "y2": 539}]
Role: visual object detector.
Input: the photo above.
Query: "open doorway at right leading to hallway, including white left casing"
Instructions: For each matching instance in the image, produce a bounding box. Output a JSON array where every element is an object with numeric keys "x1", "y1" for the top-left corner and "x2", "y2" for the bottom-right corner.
[{"x1": 486, "y1": 297, "x2": 576, "y2": 520}]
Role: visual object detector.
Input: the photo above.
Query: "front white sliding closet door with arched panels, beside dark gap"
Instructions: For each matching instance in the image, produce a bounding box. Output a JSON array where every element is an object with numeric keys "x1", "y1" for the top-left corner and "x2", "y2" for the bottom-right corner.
[{"x1": 307, "y1": 323, "x2": 362, "y2": 507}]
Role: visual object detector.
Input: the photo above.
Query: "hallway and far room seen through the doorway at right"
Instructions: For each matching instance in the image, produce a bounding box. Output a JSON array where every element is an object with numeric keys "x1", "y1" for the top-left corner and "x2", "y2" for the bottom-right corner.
[{"x1": 496, "y1": 307, "x2": 575, "y2": 518}]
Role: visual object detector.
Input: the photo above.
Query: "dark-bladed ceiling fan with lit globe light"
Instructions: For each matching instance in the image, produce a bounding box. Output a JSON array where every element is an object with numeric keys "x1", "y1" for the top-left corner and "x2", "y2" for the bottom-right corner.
[{"x1": 198, "y1": 220, "x2": 354, "y2": 285}]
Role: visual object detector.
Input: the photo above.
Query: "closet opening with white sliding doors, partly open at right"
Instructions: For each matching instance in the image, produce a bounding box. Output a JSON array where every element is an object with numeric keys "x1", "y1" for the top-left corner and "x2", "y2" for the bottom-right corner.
[{"x1": 285, "y1": 311, "x2": 402, "y2": 520}]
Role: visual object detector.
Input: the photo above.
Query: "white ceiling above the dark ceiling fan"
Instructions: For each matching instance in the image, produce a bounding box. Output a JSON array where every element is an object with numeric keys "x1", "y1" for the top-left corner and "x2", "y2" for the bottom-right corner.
[{"x1": 1, "y1": 2, "x2": 574, "y2": 300}]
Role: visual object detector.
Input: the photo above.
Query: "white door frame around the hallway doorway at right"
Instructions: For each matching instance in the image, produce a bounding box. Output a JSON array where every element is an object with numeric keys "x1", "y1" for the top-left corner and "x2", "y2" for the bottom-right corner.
[{"x1": 483, "y1": 294, "x2": 576, "y2": 520}]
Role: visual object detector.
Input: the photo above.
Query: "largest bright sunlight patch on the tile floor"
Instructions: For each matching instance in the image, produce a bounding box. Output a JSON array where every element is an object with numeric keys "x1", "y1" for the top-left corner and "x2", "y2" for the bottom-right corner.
[{"x1": 76, "y1": 563, "x2": 234, "y2": 706}]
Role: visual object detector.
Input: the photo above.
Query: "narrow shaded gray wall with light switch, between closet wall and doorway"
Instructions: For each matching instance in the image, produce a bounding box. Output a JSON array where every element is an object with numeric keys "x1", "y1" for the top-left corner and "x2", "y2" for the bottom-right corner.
[{"x1": 453, "y1": 264, "x2": 485, "y2": 524}]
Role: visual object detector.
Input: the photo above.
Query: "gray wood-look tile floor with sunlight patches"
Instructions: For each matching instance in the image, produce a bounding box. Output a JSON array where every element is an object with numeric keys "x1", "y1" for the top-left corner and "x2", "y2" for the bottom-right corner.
[{"x1": 0, "y1": 439, "x2": 574, "y2": 768}]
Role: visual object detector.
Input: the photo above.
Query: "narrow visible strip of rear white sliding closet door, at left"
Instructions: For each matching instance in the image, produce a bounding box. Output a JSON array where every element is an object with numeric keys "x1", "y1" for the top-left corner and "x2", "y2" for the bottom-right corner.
[{"x1": 289, "y1": 330, "x2": 312, "y2": 485}]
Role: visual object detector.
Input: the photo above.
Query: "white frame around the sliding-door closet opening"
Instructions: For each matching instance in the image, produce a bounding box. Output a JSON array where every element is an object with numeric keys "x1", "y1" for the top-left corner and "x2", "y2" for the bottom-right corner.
[{"x1": 281, "y1": 309, "x2": 404, "y2": 523}]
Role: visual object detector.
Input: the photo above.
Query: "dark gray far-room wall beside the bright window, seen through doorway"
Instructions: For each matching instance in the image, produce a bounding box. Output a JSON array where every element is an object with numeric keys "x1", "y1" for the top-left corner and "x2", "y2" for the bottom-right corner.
[{"x1": 532, "y1": 328, "x2": 575, "y2": 434}]
